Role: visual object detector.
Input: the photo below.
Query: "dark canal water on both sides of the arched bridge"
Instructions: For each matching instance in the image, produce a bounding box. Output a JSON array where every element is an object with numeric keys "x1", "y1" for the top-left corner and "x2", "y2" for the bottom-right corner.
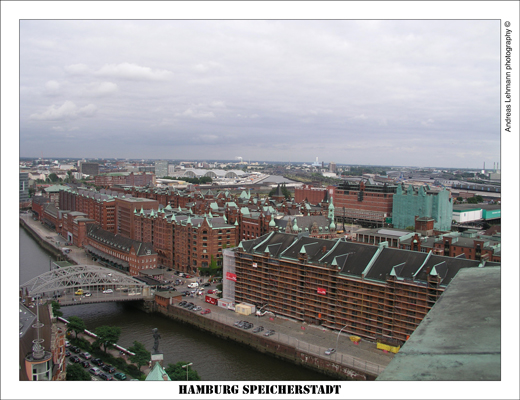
[{"x1": 20, "y1": 227, "x2": 330, "y2": 381}]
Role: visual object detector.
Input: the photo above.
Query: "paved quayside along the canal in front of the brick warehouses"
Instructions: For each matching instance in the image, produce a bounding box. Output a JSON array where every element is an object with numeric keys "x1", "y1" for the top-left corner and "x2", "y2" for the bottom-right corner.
[{"x1": 20, "y1": 214, "x2": 394, "y2": 375}]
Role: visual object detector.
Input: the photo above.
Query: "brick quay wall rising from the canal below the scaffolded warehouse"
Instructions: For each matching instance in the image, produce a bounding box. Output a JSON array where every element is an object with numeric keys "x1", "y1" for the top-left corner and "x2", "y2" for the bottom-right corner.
[{"x1": 132, "y1": 301, "x2": 377, "y2": 381}]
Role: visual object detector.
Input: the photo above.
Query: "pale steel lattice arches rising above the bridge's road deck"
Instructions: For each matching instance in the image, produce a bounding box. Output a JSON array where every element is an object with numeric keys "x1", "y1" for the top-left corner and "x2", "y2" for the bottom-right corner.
[{"x1": 20, "y1": 265, "x2": 147, "y2": 296}]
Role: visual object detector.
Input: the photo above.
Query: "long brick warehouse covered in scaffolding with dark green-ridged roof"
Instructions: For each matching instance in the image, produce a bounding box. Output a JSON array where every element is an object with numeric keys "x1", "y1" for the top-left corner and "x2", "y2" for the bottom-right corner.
[{"x1": 223, "y1": 232, "x2": 499, "y2": 343}]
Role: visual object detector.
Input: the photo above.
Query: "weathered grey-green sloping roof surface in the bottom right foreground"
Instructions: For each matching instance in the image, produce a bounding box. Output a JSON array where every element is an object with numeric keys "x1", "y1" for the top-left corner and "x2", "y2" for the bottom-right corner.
[{"x1": 377, "y1": 267, "x2": 501, "y2": 381}]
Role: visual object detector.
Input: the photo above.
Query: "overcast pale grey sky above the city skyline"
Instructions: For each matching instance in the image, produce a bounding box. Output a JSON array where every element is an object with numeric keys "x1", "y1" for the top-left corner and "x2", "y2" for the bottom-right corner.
[{"x1": 20, "y1": 20, "x2": 500, "y2": 168}]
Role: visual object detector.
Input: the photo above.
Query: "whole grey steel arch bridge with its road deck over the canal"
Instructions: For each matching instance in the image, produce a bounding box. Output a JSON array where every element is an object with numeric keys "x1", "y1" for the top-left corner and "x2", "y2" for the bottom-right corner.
[{"x1": 20, "y1": 265, "x2": 151, "y2": 305}]
